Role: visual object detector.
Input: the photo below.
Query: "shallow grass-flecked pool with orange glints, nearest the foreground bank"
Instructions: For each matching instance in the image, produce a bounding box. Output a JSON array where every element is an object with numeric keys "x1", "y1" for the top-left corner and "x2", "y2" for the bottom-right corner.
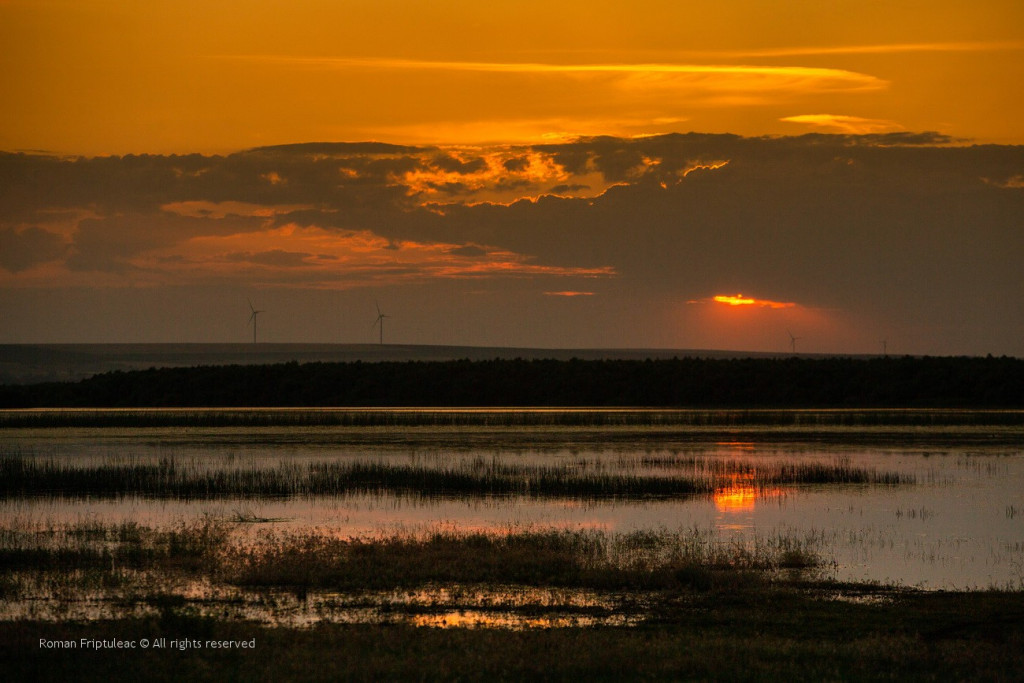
[{"x1": 0, "y1": 575, "x2": 649, "y2": 631}]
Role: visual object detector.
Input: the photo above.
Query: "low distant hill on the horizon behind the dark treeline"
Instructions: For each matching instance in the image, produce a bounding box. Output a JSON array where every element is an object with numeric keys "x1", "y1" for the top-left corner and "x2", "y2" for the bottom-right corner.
[{"x1": 0, "y1": 344, "x2": 804, "y2": 384}]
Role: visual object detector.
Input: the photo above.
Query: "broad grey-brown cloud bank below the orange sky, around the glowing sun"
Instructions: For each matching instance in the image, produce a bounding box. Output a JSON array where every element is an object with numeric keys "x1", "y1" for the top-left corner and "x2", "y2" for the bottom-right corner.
[{"x1": 0, "y1": 132, "x2": 1024, "y2": 353}]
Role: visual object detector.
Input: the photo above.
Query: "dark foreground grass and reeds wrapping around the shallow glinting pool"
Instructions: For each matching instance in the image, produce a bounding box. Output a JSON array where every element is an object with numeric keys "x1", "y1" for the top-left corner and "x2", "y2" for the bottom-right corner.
[{"x1": 8, "y1": 519, "x2": 1024, "y2": 681}]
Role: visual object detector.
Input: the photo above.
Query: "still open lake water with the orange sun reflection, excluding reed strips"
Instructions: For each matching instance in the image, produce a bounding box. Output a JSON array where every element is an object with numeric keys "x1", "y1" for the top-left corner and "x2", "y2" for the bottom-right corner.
[{"x1": 0, "y1": 419, "x2": 1024, "y2": 590}]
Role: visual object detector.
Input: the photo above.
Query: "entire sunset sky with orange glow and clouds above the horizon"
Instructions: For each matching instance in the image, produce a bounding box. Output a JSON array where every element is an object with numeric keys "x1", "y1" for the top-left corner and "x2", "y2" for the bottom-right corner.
[{"x1": 0, "y1": 0, "x2": 1024, "y2": 355}]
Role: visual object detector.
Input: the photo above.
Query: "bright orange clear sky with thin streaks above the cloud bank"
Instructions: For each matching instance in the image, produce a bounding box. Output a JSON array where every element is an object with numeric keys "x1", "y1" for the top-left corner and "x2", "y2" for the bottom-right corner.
[{"x1": 0, "y1": 0, "x2": 1024, "y2": 155}]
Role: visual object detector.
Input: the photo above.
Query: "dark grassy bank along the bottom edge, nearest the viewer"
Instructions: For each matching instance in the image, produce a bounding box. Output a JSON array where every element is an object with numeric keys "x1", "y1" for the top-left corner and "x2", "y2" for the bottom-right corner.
[{"x1": 8, "y1": 590, "x2": 1024, "y2": 681}]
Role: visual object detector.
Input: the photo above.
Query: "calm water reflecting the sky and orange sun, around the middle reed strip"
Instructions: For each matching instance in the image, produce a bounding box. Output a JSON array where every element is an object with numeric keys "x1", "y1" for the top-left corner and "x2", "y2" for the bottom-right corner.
[{"x1": 0, "y1": 430, "x2": 1024, "y2": 588}]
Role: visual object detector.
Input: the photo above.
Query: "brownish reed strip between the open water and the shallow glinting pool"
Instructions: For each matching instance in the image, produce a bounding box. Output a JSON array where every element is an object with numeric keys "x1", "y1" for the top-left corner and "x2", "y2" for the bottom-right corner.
[{"x1": 0, "y1": 517, "x2": 825, "y2": 591}]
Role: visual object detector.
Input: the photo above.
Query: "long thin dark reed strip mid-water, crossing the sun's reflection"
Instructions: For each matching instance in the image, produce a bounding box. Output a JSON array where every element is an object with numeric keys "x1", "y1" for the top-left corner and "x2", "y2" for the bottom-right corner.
[{"x1": 0, "y1": 456, "x2": 912, "y2": 500}]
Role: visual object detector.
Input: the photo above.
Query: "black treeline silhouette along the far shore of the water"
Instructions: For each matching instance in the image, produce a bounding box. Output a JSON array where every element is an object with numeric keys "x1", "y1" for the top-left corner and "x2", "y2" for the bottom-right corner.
[{"x1": 0, "y1": 356, "x2": 1024, "y2": 408}]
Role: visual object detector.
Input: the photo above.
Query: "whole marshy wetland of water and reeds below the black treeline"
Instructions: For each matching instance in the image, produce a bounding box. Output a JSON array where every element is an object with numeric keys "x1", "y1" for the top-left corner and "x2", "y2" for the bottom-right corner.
[{"x1": 6, "y1": 409, "x2": 1024, "y2": 678}]
